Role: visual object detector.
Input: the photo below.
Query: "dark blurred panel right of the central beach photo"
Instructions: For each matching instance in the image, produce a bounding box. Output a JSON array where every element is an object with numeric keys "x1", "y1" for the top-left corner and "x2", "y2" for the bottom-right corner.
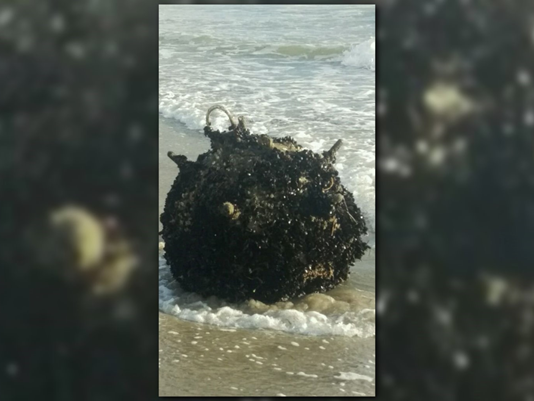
[{"x1": 377, "y1": 0, "x2": 534, "y2": 400}]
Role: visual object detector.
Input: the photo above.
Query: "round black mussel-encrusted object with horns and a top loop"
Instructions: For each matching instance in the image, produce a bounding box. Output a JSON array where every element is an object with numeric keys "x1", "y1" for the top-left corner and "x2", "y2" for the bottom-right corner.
[{"x1": 161, "y1": 107, "x2": 368, "y2": 303}]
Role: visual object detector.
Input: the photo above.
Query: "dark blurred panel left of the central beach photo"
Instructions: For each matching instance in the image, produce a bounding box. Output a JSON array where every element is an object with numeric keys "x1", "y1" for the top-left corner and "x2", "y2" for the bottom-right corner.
[{"x1": 0, "y1": 0, "x2": 158, "y2": 400}]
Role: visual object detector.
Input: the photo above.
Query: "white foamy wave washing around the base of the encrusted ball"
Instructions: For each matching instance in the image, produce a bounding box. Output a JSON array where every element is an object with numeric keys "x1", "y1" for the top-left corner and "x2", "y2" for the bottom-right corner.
[{"x1": 159, "y1": 254, "x2": 375, "y2": 338}]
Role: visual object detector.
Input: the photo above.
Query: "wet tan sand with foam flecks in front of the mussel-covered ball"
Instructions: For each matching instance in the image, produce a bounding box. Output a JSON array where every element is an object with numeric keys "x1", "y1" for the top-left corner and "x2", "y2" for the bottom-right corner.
[{"x1": 159, "y1": 313, "x2": 375, "y2": 397}]
